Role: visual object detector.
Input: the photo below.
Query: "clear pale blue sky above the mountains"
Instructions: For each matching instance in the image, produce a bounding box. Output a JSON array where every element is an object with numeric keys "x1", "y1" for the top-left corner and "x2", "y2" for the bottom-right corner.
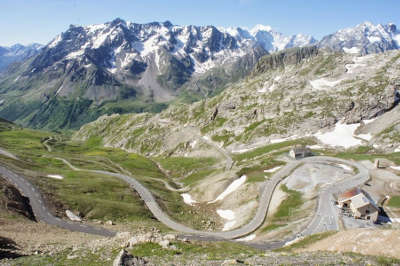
[{"x1": 0, "y1": 0, "x2": 400, "y2": 46}]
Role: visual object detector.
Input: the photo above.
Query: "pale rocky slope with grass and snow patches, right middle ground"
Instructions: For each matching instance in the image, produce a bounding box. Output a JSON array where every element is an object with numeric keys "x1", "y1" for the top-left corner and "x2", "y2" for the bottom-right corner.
[{"x1": 75, "y1": 48, "x2": 400, "y2": 154}]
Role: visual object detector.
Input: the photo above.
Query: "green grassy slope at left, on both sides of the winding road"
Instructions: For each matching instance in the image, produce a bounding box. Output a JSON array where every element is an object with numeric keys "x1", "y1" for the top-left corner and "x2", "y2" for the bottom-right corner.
[{"x1": 0, "y1": 124, "x2": 216, "y2": 227}]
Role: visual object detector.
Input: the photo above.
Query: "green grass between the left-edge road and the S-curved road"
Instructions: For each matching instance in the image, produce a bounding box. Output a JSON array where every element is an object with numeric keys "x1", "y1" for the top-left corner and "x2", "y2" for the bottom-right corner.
[{"x1": 0, "y1": 129, "x2": 155, "y2": 221}]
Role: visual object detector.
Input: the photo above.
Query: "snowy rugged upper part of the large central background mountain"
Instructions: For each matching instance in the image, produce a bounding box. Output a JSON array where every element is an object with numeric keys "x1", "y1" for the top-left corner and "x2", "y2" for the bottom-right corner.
[{"x1": 37, "y1": 19, "x2": 314, "y2": 76}]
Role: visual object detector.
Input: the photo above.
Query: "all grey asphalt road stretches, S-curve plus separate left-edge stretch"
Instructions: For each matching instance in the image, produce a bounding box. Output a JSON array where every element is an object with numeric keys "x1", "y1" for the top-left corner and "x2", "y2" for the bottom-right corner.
[{"x1": 0, "y1": 148, "x2": 369, "y2": 246}]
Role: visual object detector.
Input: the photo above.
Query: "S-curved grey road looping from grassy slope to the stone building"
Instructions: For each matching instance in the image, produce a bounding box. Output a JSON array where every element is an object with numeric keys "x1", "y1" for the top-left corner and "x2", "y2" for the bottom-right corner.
[{"x1": 58, "y1": 156, "x2": 369, "y2": 239}]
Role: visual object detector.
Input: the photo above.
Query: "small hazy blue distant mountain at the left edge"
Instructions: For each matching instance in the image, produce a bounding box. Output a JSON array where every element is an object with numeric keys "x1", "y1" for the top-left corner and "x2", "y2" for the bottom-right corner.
[{"x1": 0, "y1": 43, "x2": 43, "y2": 72}]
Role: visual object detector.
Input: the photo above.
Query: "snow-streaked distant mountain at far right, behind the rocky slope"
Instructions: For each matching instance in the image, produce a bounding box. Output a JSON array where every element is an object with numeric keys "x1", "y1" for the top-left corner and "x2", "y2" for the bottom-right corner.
[{"x1": 319, "y1": 22, "x2": 400, "y2": 54}]
